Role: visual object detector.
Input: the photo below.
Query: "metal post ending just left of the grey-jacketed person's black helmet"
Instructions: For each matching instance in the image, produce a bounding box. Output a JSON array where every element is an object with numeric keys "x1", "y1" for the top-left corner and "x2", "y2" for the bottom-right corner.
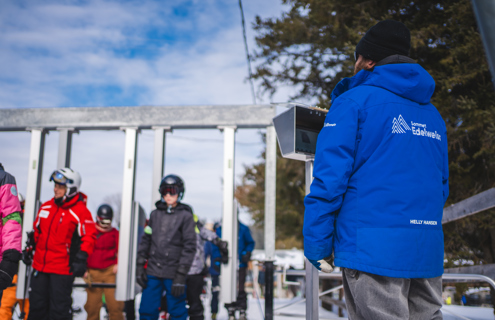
[{"x1": 151, "y1": 127, "x2": 171, "y2": 208}]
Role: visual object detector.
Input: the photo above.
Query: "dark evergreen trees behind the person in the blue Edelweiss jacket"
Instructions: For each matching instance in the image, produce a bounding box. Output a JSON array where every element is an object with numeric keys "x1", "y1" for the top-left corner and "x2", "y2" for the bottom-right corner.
[{"x1": 237, "y1": 0, "x2": 495, "y2": 258}]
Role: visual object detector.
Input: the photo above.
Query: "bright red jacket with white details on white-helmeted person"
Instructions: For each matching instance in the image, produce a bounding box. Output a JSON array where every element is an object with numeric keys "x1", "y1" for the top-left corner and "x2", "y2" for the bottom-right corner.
[{"x1": 33, "y1": 192, "x2": 96, "y2": 275}]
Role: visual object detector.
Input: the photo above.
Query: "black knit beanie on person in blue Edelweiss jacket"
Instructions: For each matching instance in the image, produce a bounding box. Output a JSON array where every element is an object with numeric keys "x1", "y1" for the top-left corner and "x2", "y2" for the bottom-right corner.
[{"x1": 356, "y1": 20, "x2": 411, "y2": 62}]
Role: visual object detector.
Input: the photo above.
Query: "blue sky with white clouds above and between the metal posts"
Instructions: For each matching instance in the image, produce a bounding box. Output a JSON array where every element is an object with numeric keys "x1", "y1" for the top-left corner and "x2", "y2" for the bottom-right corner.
[{"x1": 0, "y1": 0, "x2": 298, "y2": 224}]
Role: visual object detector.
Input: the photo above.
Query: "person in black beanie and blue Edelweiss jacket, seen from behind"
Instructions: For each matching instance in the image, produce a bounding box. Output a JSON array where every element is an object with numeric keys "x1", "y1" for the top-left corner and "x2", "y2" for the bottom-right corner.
[{"x1": 303, "y1": 20, "x2": 449, "y2": 320}]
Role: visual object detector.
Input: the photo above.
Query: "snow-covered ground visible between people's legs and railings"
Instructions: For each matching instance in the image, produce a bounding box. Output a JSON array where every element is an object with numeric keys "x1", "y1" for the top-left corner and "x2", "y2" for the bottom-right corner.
[{"x1": 8, "y1": 288, "x2": 495, "y2": 320}]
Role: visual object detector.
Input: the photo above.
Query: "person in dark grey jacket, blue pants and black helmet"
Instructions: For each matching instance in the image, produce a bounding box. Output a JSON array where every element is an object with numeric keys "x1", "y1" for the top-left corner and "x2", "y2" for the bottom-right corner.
[{"x1": 136, "y1": 175, "x2": 196, "y2": 320}]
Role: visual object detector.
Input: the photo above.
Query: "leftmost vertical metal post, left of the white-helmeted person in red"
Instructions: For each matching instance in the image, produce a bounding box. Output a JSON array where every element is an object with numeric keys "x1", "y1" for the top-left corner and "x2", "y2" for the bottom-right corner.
[{"x1": 16, "y1": 129, "x2": 46, "y2": 299}]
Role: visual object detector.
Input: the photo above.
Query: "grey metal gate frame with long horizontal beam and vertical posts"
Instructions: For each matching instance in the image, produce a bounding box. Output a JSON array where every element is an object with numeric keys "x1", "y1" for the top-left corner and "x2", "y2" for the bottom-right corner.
[{"x1": 0, "y1": 105, "x2": 277, "y2": 303}]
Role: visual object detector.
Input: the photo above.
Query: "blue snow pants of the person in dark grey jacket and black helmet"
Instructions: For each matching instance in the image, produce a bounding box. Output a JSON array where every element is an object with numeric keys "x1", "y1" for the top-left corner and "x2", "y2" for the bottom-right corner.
[{"x1": 139, "y1": 275, "x2": 187, "y2": 320}]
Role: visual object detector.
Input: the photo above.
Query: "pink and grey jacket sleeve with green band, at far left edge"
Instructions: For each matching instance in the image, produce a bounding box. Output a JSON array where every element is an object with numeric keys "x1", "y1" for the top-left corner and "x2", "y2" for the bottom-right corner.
[{"x1": 0, "y1": 178, "x2": 22, "y2": 253}]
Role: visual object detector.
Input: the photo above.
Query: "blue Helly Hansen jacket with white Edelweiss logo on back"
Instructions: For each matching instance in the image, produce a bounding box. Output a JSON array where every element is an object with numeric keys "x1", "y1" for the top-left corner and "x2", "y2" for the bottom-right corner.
[{"x1": 303, "y1": 63, "x2": 449, "y2": 278}]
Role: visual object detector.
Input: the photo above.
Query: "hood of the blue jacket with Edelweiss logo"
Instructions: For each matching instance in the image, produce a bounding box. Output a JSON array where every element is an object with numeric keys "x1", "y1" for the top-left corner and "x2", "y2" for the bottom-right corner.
[{"x1": 332, "y1": 63, "x2": 435, "y2": 104}]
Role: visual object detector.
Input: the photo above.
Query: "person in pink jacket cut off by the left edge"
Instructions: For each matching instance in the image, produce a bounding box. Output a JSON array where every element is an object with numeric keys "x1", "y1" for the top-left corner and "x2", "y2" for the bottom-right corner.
[{"x1": 0, "y1": 163, "x2": 22, "y2": 299}]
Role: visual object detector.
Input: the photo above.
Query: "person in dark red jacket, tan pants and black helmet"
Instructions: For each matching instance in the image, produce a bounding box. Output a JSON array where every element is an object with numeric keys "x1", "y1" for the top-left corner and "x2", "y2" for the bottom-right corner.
[{"x1": 84, "y1": 204, "x2": 124, "y2": 320}]
